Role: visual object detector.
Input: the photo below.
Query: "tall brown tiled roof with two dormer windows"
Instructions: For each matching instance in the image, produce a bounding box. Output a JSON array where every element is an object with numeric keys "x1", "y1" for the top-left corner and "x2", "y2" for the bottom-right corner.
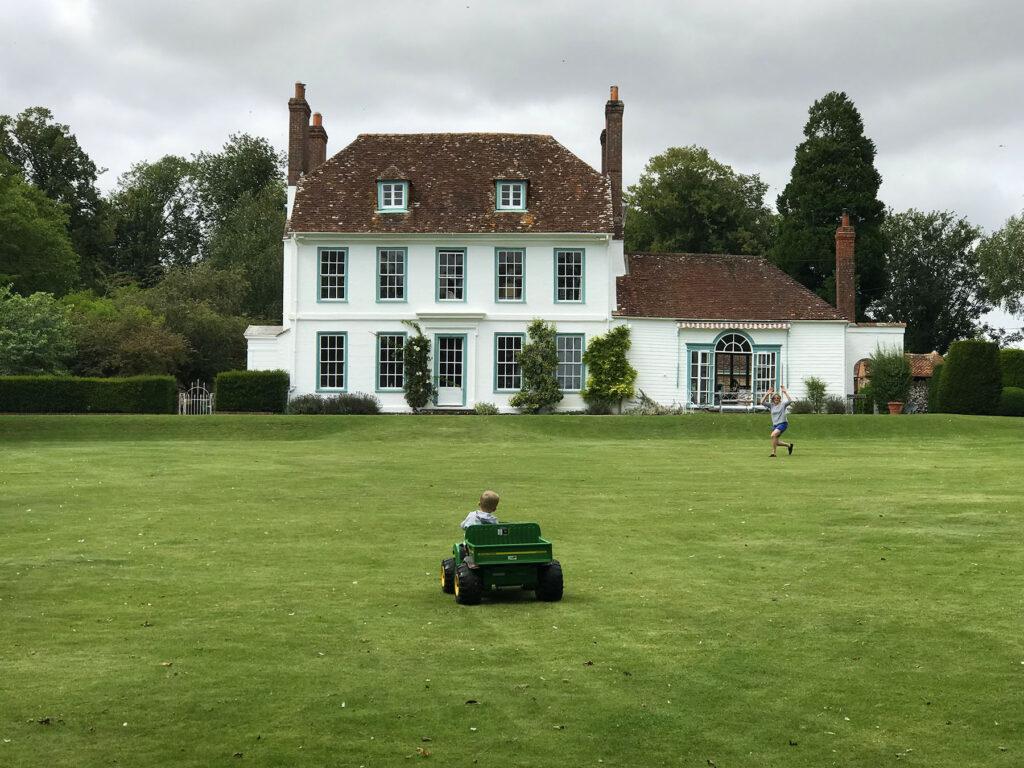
[{"x1": 289, "y1": 133, "x2": 612, "y2": 233}]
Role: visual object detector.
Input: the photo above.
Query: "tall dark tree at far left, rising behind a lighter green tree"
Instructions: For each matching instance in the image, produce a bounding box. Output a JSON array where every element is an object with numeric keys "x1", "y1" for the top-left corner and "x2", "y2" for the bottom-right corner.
[{"x1": 0, "y1": 106, "x2": 112, "y2": 285}]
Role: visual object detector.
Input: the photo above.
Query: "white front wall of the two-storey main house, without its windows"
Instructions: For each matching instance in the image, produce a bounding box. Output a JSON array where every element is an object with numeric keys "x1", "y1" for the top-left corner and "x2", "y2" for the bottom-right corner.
[{"x1": 249, "y1": 234, "x2": 625, "y2": 411}]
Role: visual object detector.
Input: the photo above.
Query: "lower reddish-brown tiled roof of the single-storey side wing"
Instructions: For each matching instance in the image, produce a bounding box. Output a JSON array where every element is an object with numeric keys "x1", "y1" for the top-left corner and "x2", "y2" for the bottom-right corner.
[{"x1": 615, "y1": 253, "x2": 843, "y2": 321}]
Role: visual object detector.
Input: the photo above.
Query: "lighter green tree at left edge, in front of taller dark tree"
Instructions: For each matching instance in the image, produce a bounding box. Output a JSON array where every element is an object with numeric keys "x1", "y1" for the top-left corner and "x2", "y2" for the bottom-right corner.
[{"x1": 0, "y1": 158, "x2": 78, "y2": 294}]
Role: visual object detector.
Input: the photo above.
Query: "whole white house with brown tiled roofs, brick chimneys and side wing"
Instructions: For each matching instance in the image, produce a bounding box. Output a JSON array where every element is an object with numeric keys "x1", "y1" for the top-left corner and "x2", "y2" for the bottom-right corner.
[{"x1": 246, "y1": 83, "x2": 903, "y2": 412}]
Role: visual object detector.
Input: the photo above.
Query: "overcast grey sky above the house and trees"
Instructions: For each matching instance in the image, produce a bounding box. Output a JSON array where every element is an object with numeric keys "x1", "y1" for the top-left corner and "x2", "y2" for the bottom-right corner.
[{"x1": 0, "y1": 0, "x2": 1024, "y2": 325}]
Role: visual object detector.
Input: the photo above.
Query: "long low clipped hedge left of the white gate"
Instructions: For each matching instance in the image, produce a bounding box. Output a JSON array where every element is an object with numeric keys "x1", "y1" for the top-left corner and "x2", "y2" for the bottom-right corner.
[{"x1": 0, "y1": 376, "x2": 178, "y2": 414}]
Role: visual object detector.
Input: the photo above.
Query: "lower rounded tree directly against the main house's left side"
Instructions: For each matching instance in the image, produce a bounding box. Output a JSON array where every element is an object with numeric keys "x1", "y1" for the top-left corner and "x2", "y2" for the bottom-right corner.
[{"x1": 208, "y1": 183, "x2": 285, "y2": 325}]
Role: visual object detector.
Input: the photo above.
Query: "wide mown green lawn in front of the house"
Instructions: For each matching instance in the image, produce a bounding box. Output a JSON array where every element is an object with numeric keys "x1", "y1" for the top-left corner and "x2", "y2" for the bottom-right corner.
[{"x1": 0, "y1": 416, "x2": 1024, "y2": 768}]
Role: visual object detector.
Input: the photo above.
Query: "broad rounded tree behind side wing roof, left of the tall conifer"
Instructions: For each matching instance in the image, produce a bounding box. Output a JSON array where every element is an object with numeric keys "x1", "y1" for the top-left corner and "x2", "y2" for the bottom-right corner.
[{"x1": 626, "y1": 146, "x2": 773, "y2": 254}]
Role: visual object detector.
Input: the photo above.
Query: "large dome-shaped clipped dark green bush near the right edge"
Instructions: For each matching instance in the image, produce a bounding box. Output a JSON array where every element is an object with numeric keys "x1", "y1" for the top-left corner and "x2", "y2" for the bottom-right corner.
[{"x1": 939, "y1": 339, "x2": 1002, "y2": 415}]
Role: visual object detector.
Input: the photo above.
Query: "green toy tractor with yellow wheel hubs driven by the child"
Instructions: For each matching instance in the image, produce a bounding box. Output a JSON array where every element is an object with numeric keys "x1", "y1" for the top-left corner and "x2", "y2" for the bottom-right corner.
[{"x1": 441, "y1": 522, "x2": 562, "y2": 605}]
